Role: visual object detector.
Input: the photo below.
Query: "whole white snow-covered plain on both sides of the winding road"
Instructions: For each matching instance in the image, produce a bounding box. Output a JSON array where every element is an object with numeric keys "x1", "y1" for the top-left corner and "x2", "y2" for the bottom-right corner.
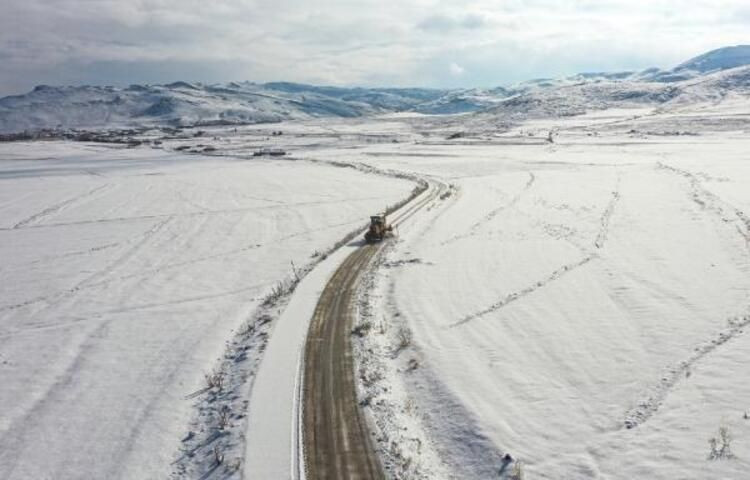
[{"x1": 0, "y1": 88, "x2": 750, "y2": 479}]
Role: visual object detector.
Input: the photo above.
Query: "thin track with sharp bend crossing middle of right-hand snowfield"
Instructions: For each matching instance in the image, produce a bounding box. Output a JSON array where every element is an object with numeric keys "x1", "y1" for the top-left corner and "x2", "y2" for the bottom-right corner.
[{"x1": 448, "y1": 172, "x2": 621, "y2": 328}]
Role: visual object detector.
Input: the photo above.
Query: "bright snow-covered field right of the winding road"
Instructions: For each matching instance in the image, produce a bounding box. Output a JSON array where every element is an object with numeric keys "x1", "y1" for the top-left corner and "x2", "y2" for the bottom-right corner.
[{"x1": 340, "y1": 109, "x2": 750, "y2": 479}]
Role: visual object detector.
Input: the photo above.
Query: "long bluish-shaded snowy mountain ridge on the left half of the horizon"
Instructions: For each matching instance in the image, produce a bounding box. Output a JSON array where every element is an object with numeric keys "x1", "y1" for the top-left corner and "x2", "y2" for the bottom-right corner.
[{"x1": 0, "y1": 82, "x2": 444, "y2": 133}]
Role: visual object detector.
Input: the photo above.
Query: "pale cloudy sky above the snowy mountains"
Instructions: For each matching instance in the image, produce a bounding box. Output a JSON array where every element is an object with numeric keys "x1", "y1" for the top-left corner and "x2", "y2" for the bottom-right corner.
[{"x1": 0, "y1": 0, "x2": 750, "y2": 95}]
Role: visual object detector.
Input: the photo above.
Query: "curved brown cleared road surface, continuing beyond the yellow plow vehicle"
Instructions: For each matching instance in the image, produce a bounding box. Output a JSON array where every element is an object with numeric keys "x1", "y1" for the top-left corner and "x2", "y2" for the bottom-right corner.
[{"x1": 301, "y1": 183, "x2": 445, "y2": 480}]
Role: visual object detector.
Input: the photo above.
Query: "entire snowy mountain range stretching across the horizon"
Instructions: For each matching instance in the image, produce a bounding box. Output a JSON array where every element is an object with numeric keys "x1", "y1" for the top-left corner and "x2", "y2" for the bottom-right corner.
[{"x1": 0, "y1": 45, "x2": 750, "y2": 133}]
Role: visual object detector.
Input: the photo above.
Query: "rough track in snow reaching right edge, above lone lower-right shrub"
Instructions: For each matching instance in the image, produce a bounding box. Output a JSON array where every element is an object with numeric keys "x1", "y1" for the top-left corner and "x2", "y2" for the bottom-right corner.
[{"x1": 623, "y1": 314, "x2": 750, "y2": 429}]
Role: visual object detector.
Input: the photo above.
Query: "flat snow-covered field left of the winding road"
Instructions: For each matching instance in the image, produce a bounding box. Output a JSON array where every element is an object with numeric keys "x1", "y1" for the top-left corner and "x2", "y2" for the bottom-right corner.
[{"x1": 0, "y1": 142, "x2": 413, "y2": 479}]
